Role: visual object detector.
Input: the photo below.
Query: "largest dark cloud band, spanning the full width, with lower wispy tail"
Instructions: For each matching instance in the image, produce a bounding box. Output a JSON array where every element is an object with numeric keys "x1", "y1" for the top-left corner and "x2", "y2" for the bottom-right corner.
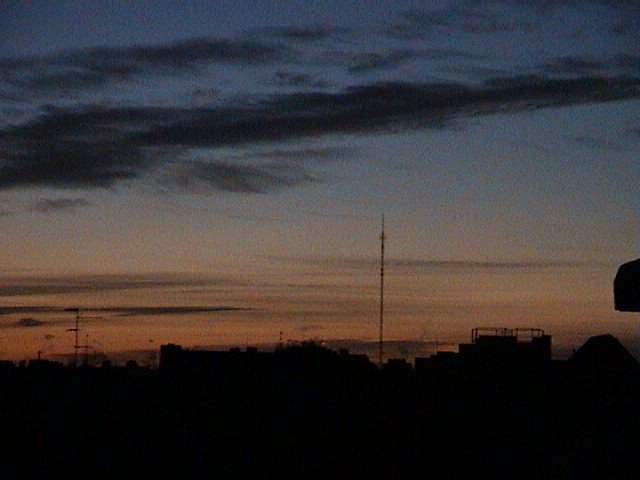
[{"x1": 0, "y1": 75, "x2": 640, "y2": 193}]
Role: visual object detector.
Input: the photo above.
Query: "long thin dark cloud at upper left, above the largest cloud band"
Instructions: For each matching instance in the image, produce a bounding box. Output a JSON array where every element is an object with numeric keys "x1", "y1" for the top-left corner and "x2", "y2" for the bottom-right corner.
[{"x1": 0, "y1": 38, "x2": 288, "y2": 91}]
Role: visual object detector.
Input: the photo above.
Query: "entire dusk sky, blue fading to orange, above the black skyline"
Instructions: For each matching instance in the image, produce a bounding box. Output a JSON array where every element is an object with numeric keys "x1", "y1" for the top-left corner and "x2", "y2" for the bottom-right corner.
[{"x1": 0, "y1": 0, "x2": 640, "y2": 359}]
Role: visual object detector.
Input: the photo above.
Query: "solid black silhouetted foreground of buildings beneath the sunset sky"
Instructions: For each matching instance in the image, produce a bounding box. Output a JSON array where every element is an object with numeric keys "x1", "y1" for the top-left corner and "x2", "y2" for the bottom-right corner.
[{"x1": 0, "y1": 338, "x2": 640, "y2": 479}]
